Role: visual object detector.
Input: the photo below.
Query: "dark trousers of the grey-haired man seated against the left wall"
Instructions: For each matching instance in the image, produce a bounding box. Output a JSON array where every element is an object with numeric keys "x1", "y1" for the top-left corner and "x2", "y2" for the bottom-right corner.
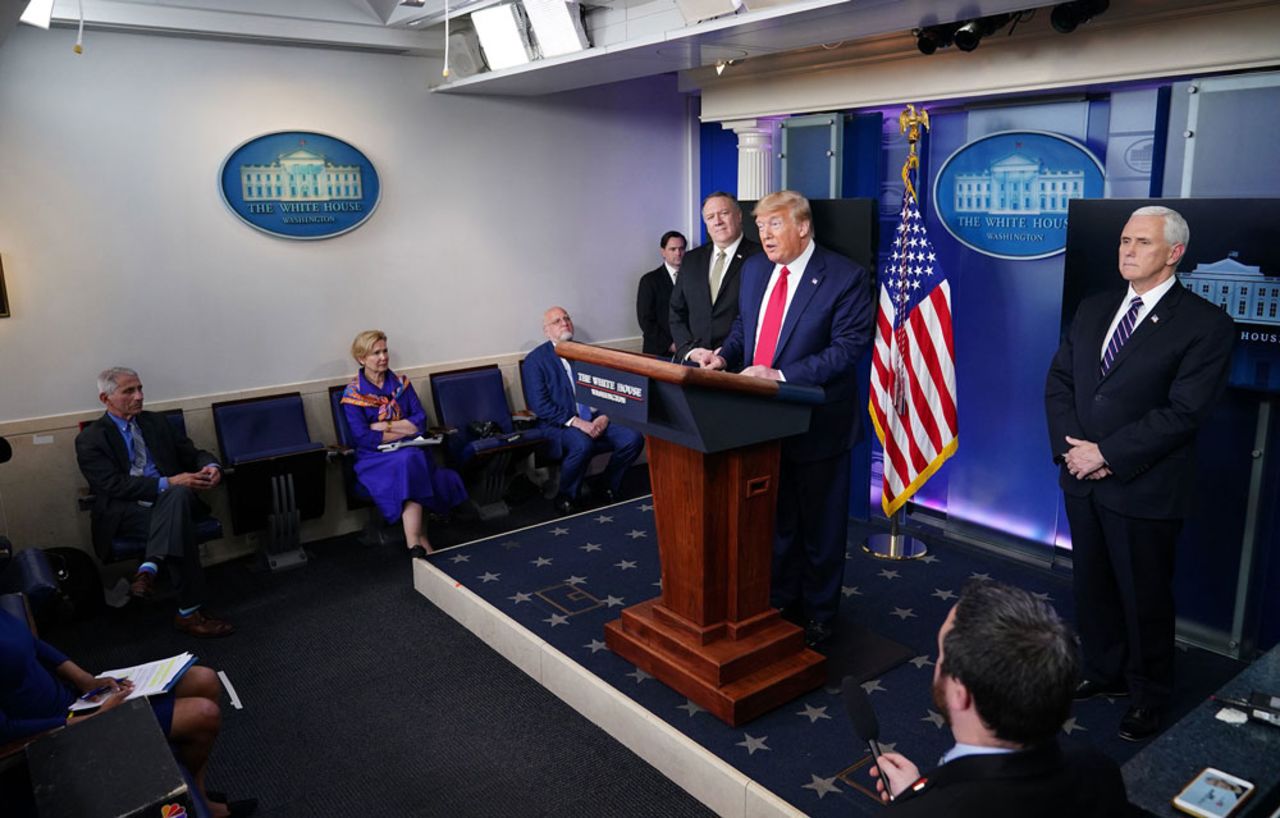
[{"x1": 116, "y1": 485, "x2": 205, "y2": 608}]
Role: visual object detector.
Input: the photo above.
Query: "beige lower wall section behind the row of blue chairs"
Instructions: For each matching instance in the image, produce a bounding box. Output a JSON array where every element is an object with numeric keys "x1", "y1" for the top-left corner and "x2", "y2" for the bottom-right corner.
[{"x1": 0, "y1": 338, "x2": 641, "y2": 562}]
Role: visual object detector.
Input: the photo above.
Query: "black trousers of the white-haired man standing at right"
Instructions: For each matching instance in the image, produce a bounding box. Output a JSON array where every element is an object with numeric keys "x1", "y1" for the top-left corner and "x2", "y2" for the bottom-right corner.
[{"x1": 1066, "y1": 495, "x2": 1183, "y2": 708}]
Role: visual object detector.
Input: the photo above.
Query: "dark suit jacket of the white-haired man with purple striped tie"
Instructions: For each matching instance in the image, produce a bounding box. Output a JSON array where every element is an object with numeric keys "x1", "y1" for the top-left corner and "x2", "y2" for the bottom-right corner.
[{"x1": 1044, "y1": 284, "x2": 1235, "y2": 520}]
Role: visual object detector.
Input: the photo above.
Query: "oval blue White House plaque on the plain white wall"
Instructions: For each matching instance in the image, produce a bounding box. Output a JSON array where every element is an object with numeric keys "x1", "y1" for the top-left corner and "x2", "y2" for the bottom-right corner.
[{"x1": 218, "y1": 131, "x2": 381, "y2": 239}]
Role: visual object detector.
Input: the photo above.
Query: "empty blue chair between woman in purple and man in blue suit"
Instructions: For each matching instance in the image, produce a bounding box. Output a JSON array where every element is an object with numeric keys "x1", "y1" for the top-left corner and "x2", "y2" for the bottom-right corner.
[{"x1": 430, "y1": 364, "x2": 545, "y2": 520}]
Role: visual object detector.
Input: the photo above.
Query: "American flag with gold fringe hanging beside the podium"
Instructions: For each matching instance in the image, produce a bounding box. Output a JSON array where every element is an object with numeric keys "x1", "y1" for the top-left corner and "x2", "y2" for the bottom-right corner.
[{"x1": 869, "y1": 177, "x2": 959, "y2": 517}]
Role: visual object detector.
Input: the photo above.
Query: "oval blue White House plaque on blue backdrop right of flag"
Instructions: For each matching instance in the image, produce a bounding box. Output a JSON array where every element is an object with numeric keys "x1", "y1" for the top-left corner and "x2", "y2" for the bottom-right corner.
[{"x1": 933, "y1": 131, "x2": 1103, "y2": 259}]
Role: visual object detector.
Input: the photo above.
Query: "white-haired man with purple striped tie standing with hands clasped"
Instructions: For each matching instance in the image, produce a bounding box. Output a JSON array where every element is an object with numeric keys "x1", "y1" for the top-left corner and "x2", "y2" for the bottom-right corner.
[{"x1": 1044, "y1": 206, "x2": 1234, "y2": 741}]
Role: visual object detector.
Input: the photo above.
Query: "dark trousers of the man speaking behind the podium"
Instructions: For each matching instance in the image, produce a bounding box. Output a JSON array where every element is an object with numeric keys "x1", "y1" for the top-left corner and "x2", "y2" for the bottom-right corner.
[{"x1": 769, "y1": 452, "x2": 850, "y2": 627}]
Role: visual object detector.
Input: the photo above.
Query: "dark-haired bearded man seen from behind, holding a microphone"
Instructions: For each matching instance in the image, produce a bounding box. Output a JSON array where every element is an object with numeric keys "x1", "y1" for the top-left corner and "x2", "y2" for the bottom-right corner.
[{"x1": 872, "y1": 581, "x2": 1132, "y2": 818}]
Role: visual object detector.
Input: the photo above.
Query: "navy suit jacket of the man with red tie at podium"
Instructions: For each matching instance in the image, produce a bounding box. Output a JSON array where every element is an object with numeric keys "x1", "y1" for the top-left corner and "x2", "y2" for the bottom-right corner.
[{"x1": 716, "y1": 246, "x2": 874, "y2": 461}]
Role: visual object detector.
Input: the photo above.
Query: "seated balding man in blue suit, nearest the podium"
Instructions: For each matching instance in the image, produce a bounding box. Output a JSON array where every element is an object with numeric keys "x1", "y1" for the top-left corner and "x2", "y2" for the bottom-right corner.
[{"x1": 520, "y1": 307, "x2": 644, "y2": 515}]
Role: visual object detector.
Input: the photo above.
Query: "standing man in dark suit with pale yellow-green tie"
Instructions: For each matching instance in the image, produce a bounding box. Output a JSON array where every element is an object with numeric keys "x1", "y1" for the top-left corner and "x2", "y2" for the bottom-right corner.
[{"x1": 671, "y1": 191, "x2": 760, "y2": 360}]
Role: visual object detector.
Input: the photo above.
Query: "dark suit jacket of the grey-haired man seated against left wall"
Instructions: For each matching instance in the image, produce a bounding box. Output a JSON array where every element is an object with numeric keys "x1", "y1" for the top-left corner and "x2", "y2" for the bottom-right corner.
[{"x1": 76, "y1": 412, "x2": 218, "y2": 556}]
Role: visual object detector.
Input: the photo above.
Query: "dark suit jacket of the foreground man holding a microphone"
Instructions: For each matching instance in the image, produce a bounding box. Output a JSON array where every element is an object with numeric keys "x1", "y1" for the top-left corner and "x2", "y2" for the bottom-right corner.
[{"x1": 886, "y1": 741, "x2": 1135, "y2": 818}]
